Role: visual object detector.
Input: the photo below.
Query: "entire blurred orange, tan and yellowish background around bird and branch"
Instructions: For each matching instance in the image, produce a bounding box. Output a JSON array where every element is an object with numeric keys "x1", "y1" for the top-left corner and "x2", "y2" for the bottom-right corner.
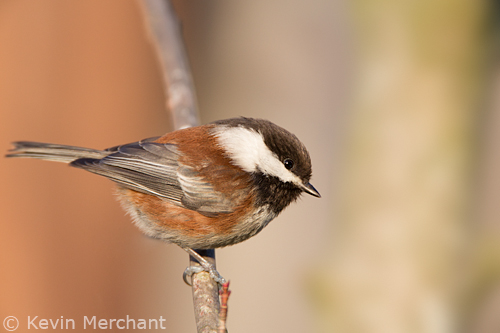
[{"x1": 0, "y1": 0, "x2": 500, "y2": 333}]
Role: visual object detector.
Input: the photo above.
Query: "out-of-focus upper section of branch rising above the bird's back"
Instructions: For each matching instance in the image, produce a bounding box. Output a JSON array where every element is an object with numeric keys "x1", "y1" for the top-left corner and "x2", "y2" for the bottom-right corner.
[{"x1": 140, "y1": 0, "x2": 200, "y2": 129}]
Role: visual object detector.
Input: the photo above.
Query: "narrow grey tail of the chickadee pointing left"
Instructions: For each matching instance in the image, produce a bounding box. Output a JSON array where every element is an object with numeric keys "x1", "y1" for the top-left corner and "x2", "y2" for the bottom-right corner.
[{"x1": 5, "y1": 141, "x2": 109, "y2": 163}]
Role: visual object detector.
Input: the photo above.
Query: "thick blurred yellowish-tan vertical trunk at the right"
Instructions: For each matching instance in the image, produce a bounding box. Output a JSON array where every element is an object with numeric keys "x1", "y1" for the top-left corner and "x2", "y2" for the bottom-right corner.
[{"x1": 314, "y1": 0, "x2": 492, "y2": 333}]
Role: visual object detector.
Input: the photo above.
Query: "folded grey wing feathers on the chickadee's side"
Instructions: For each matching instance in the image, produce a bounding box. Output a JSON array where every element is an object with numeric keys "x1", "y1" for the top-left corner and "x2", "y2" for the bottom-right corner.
[{"x1": 71, "y1": 139, "x2": 233, "y2": 216}]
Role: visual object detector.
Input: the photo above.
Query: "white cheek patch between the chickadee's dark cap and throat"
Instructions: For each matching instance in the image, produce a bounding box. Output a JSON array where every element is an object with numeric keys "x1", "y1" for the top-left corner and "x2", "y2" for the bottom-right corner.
[{"x1": 214, "y1": 127, "x2": 302, "y2": 184}]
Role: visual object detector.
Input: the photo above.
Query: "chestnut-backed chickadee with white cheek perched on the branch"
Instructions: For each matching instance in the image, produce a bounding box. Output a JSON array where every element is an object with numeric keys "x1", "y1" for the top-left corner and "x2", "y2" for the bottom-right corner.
[{"x1": 6, "y1": 117, "x2": 320, "y2": 282}]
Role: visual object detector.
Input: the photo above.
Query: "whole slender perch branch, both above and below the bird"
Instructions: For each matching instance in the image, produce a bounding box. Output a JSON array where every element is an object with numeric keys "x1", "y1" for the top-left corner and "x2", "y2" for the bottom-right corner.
[{"x1": 140, "y1": 0, "x2": 220, "y2": 332}]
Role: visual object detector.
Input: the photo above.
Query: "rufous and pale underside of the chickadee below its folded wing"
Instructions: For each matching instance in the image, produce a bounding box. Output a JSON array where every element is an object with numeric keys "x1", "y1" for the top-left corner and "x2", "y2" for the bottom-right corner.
[{"x1": 114, "y1": 188, "x2": 276, "y2": 249}]
